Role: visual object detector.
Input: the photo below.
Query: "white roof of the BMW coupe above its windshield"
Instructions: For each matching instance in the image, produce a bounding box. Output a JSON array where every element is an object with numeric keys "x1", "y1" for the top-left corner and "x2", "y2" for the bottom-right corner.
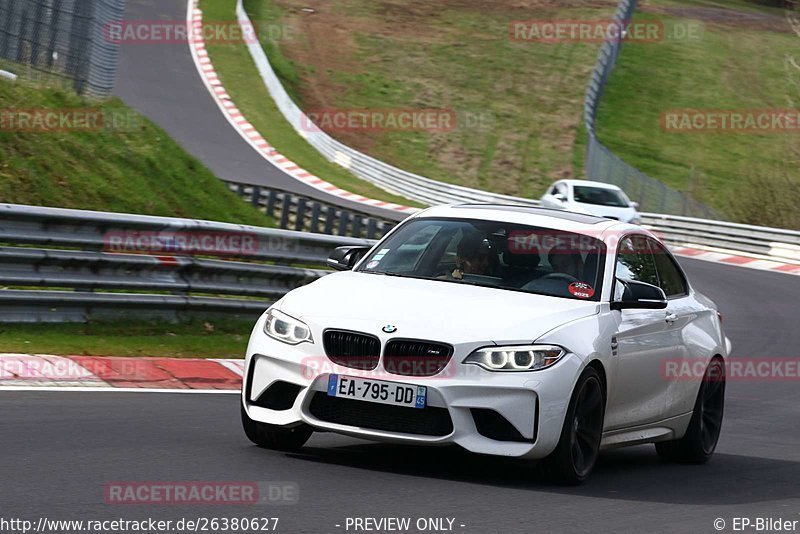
[{"x1": 414, "y1": 203, "x2": 627, "y2": 236}]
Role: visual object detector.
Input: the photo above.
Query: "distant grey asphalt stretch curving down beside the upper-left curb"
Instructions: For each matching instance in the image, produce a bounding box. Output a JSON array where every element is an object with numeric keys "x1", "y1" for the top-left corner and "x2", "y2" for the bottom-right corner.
[{"x1": 115, "y1": 0, "x2": 404, "y2": 220}]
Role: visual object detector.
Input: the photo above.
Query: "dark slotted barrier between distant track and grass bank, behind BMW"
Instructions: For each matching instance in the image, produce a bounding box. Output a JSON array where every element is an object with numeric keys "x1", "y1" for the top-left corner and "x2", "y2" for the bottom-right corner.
[{"x1": 223, "y1": 182, "x2": 406, "y2": 239}]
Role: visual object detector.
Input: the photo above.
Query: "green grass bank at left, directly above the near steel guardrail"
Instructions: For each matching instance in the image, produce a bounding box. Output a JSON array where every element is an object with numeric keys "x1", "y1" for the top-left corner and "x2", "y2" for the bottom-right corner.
[{"x1": 0, "y1": 77, "x2": 271, "y2": 226}]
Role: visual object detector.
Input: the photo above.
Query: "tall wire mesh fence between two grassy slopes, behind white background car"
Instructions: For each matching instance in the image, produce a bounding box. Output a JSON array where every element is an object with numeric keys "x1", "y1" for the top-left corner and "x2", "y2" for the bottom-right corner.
[{"x1": 583, "y1": 0, "x2": 720, "y2": 219}]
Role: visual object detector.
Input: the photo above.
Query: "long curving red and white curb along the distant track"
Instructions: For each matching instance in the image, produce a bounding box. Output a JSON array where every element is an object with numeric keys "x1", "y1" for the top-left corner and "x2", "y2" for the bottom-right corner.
[{"x1": 187, "y1": 0, "x2": 418, "y2": 214}]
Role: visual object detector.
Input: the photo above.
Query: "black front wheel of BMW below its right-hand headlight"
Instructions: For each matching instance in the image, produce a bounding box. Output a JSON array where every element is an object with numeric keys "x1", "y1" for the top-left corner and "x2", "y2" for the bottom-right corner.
[{"x1": 543, "y1": 367, "x2": 606, "y2": 486}]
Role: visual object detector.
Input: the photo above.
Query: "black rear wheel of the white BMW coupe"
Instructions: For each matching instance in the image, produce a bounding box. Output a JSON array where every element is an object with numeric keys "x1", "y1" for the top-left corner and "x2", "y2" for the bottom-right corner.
[{"x1": 656, "y1": 358, "x2": 726, "y2": 464}]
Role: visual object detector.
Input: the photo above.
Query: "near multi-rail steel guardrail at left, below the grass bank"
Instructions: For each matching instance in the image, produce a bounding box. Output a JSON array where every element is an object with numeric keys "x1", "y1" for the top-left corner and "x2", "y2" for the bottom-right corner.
[{"x1": 0, "y1": 204, "x2": 369, "y2": 322}]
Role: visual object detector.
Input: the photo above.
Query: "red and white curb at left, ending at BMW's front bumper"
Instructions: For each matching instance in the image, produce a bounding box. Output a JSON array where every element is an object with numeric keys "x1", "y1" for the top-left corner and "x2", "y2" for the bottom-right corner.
[{"x1": 0, "y1": 354, "x2": 244, "y2": 393}]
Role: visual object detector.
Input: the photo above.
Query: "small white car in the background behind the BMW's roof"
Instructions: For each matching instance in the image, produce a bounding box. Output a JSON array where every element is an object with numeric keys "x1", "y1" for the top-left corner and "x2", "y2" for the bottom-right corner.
[{"x1": 541, "y1": 180, "x2": 641, "y2": 224}]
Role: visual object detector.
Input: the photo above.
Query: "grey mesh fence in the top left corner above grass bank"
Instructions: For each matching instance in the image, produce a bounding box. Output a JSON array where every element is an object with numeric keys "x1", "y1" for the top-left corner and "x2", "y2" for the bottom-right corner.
[{"x1": 0, "y1": 0, "x2": 125, "y2": 98}]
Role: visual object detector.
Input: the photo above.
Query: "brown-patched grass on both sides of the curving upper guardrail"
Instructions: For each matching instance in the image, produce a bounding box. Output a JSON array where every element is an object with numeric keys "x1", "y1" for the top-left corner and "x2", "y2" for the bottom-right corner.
[{"x1": 201, "y1": 0, "x2": 616, "y2": 200}]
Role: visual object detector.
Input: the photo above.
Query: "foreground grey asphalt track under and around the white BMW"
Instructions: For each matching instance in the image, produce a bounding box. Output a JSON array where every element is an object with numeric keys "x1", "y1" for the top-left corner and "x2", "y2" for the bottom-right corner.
[{"x1": 0, "y1": 260, "x2": 800, "y2": 534}]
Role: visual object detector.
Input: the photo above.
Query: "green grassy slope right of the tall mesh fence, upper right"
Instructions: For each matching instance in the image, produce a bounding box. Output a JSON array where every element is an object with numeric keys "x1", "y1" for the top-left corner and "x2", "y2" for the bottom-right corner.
[{"x1": 598, "y1": 0, "x2": 800, "y2": 228}]
